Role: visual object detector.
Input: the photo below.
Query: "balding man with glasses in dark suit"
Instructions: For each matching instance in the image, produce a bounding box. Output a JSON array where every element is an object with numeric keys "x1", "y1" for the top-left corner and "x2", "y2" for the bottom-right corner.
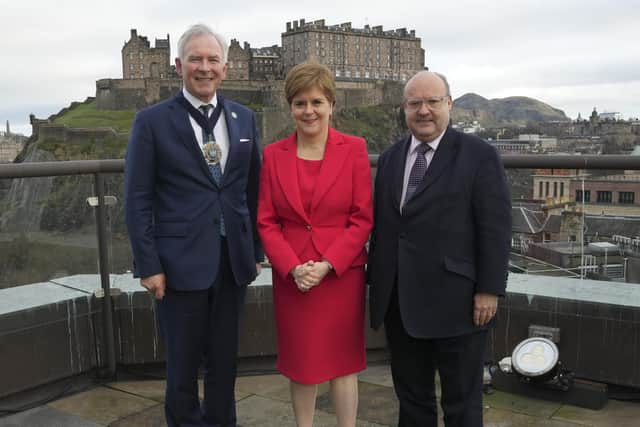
[{"x1": 368, "y1": 71, "x2": 511, "y2": 427}]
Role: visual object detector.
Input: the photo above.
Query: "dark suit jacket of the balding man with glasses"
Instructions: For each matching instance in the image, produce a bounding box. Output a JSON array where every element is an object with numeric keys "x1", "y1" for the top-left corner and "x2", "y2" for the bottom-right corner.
[{"x1": 368, "y1": 128, "x2": 511, "y2": 338}]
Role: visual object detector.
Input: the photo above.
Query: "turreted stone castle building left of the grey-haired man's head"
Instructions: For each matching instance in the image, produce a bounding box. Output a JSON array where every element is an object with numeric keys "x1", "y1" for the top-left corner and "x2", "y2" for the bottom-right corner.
[{"x1": 122, "y1": 29, "x2": 175, "y2": 79}]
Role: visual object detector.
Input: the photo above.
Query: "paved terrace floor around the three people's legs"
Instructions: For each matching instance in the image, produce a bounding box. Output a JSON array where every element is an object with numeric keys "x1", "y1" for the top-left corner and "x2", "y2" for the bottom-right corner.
[{"x1": 0, "y1": 365, "x2": 640, "y2": 427}]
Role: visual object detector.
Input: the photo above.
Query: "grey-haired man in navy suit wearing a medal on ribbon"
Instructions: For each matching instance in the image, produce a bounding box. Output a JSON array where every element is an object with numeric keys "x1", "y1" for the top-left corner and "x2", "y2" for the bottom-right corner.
[{"x1": 125, "y1": 25, "x2": 263, "y2": 426}]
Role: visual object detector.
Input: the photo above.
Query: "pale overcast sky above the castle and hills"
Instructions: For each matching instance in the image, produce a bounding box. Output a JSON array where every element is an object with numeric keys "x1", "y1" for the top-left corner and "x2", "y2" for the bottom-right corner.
[{"x1": 0, "y1": 0, "x2": 640, "y2": 134}]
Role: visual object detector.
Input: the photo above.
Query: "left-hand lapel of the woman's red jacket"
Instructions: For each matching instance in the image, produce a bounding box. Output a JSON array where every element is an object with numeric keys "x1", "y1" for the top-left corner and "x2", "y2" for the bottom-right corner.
[{"x1": 274, "y1": 132, "x2": 309, "y2": 223}]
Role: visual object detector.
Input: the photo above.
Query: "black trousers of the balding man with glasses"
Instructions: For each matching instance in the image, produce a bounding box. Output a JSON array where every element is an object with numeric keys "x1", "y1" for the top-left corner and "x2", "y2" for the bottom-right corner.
[{"x1": 385, "y1": 289, "x2": 487, "y2": 427}]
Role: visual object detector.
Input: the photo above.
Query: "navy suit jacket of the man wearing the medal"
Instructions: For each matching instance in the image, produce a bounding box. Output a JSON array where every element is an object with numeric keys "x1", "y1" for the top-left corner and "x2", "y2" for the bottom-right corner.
[{"x1": 125, "y1": 94, "x2": 263, "y2": 290}]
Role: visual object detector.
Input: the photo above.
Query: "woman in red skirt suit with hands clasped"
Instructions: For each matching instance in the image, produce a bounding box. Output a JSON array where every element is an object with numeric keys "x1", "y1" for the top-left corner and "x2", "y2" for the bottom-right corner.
[{"x1": 258, "y1": 63, "x2": 373, "y2": 427}]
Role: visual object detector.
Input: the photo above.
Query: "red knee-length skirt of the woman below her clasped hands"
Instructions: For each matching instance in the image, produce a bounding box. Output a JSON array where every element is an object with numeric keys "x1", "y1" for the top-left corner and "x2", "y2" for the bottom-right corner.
[{"x1": 273, "y1": 267, "x2": 366, "y2": 384}]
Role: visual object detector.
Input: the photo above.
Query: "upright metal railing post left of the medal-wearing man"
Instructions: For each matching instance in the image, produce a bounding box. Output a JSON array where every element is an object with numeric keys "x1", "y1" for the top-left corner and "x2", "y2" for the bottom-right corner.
[{"x1": 94, "y1": 173, "x2": 116, "y2": 378}]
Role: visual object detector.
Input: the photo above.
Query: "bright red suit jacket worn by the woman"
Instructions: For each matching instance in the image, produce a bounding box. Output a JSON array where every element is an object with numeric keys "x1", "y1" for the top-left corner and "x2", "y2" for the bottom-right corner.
[{"x1": 258, "y1": 128, "x2": 373, "y2": 278}]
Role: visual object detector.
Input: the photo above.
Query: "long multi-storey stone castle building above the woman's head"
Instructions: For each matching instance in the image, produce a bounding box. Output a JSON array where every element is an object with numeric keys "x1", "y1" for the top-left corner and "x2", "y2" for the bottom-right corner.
[{"x1": 282, "y1": 19, "x2": 425, "y2": 81}]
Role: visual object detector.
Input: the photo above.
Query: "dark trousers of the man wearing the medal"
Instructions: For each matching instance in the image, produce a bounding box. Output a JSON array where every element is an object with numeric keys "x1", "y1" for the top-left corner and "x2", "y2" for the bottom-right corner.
[{"x1": 158, "y1": 239, "x2": 246, "y2": 427}]
